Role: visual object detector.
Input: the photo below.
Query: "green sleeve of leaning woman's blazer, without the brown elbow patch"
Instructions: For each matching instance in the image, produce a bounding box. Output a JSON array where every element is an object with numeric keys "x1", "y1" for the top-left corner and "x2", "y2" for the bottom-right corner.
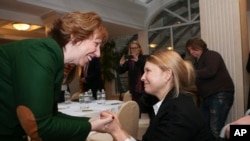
[{"x1": 13, "y1": 38, "x2": 91, "y2": 141}]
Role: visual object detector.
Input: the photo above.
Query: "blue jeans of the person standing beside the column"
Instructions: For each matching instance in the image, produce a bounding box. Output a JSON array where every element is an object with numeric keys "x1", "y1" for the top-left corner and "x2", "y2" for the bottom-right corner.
[{"x1": 200, "y1": 92, "x2": 234, "y2": 141}]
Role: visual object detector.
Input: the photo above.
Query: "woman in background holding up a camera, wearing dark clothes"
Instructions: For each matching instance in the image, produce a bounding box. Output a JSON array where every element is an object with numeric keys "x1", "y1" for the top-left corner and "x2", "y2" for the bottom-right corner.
[{"x1": 118, "y1": 41, "x2": 145, "y2": 103}]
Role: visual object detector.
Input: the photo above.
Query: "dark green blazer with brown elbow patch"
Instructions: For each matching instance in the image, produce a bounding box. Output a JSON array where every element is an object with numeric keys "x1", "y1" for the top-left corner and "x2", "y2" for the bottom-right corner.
[{"x1": 0, "y1": 38, "x2": 91, "y2": 141}]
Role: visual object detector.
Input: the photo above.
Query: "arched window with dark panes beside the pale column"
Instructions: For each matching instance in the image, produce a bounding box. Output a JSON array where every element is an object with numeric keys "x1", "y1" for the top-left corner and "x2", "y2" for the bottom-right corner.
[{"x1": 148, "y1": 0, "x2": 200, "y2": 54}]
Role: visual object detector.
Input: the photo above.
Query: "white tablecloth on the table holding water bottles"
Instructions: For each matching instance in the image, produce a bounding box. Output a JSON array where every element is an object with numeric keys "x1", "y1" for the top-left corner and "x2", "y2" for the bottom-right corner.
[{"x1": 58, "y1": 100, "x2": 123, "y2": 117}]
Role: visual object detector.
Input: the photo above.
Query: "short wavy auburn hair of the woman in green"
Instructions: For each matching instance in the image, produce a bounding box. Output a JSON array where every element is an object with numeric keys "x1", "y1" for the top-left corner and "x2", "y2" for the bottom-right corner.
[{"x1": 49, "y1": 11, "x2": 108, "y2": 48}]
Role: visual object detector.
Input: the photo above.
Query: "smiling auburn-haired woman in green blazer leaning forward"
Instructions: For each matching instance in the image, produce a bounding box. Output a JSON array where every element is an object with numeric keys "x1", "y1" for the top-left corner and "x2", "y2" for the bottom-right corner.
[{"x1": 0, "y1": 11, "x2": 112, "y2": 141}]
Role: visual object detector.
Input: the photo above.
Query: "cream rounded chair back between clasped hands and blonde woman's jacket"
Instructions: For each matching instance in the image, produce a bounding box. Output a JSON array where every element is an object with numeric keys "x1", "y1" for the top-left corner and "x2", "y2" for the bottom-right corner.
[{"x1": 117, "y1": 101, "x2": 140, "y2": 138}]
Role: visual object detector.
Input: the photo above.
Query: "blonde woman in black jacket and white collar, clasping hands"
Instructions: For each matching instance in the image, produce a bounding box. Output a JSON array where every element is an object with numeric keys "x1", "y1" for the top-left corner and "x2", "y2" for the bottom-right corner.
[{"x1": 101, "y1": 50, "x2": 211, "y2": 141}]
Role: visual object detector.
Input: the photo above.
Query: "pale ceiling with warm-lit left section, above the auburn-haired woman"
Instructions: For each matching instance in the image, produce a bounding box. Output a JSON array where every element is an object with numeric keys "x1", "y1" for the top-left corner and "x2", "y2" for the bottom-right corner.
[{"x1": 0, "y1": 0, "x2": 250, "y2": 44}]
